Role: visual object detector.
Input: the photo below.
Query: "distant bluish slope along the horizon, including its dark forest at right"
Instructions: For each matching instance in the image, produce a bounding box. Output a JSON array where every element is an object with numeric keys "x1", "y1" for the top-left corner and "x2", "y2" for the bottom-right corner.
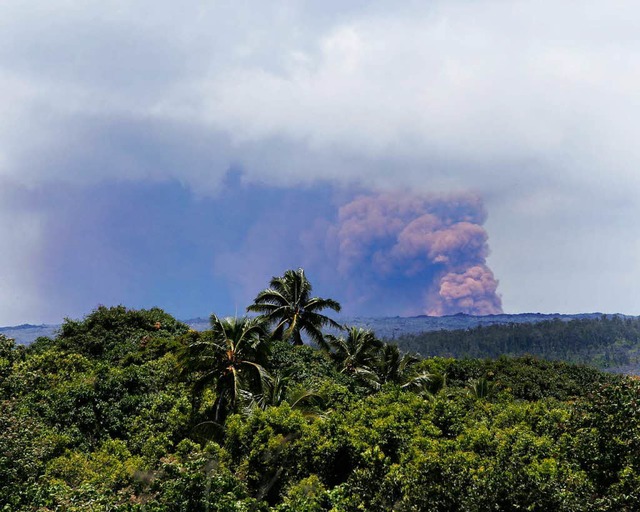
[{"x1": 0, "y1": 313, "x2": 640, "y2": 373}]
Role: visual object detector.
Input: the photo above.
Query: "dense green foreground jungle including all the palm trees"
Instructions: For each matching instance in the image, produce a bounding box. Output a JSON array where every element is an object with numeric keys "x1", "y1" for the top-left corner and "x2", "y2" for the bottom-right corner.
[{"x1": 0, "y1": 270, "x2": 640, "y2": 512}]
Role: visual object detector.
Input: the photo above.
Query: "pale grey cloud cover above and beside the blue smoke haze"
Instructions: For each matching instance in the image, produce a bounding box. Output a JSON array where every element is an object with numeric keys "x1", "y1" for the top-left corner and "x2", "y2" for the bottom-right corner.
[{"x1": 0, "y1": 0, "x2": 640, "y2": 316}]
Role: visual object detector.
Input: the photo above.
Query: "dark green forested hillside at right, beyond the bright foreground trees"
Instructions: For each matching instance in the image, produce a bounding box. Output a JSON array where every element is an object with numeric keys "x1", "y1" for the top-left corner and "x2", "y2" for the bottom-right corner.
[{"x1": 394, "y1": 315, "x2": 640, "y2": 373}]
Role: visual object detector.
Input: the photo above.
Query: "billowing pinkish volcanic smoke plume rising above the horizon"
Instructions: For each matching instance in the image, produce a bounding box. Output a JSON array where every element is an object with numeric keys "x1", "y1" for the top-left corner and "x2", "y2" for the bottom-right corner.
[{"x1": 329, "y1": 194, "x2": 502, "y2": 315}]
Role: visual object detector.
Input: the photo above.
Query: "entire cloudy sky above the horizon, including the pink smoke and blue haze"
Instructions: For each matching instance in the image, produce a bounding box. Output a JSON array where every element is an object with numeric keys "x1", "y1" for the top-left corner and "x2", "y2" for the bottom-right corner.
[{"x1": 0, "y1": 0, "x2": 640, "y2": 325}]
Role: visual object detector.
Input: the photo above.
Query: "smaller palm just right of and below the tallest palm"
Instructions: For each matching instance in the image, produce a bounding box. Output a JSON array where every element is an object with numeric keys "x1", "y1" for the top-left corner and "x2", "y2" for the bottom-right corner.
[{"x1": 319, "y1": 327, "x2": 382, "y2": 381}]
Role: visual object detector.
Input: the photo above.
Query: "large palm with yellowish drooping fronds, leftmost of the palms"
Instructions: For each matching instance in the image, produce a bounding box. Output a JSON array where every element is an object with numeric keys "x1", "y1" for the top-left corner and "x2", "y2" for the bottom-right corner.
[{"x1": 181, "y1": 315, "x2": 269, "y2": 423}]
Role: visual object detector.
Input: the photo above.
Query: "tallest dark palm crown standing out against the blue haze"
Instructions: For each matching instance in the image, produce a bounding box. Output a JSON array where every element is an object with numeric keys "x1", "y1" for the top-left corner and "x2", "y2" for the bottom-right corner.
[{"x1": 247, "y1": 268, "x2": 342, "y2": 345}]
